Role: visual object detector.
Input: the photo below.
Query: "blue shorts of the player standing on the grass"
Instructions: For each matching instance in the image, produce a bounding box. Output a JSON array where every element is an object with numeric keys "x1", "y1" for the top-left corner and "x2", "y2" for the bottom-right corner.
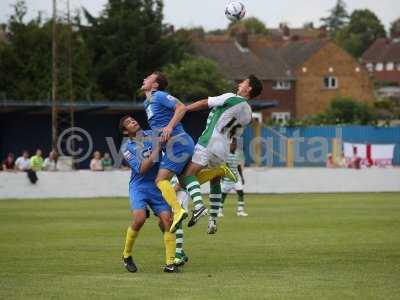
[{"x1": 129, "y1": 186, "x2": 171, "y2": 216}]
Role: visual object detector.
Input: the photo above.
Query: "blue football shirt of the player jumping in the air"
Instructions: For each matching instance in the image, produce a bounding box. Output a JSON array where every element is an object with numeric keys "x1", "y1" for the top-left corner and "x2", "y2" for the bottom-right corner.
[{"x1": 144, "y1": 91, "x2": 185, "y2": 136}]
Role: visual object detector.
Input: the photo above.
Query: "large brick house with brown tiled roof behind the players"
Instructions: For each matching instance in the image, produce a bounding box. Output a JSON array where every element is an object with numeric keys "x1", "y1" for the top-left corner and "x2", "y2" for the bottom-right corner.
[{"x1": 195, "y1": 31, "x2": 374, "y2": 122}]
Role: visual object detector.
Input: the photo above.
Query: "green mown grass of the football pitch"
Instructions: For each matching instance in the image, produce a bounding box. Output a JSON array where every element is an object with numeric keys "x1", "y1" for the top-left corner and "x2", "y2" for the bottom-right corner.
[{"x1": 0, "y1": 193, "x2": 400, "y2": 300}]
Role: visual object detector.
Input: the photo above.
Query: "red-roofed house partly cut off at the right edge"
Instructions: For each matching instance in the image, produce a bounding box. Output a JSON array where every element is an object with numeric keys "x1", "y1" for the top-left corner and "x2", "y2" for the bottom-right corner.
[{"x1": 361, "y1": 38, "x2": 400, "y2": 86}]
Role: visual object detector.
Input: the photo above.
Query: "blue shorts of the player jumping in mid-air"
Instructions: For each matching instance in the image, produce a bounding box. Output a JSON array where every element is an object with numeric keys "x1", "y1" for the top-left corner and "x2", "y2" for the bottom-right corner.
[{"x1": 160, "y1": 133, "x2": 194, "y2": 175}]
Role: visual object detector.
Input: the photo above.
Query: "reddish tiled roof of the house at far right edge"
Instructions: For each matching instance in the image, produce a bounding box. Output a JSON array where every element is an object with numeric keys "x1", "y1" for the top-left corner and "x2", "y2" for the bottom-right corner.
[{"x1": 362, "y1": 38, "x2": 400, "y2": 62}]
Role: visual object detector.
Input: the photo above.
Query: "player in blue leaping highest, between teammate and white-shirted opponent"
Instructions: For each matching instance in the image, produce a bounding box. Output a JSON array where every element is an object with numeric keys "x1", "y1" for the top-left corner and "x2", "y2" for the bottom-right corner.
[{"x1": 142, "y1": 72, "x2": 194, "y2": 232}]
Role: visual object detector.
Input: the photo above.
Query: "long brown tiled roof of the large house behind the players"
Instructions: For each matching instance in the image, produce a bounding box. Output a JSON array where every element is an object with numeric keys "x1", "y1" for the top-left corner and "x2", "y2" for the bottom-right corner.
[{"x1": 195, "y1": 36, "x2": 327, "y2": 80}]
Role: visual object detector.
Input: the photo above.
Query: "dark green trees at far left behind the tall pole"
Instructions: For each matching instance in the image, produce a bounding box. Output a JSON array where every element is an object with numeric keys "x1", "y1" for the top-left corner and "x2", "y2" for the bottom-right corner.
[{"x1": 0, "y1": 1, "x2": 100, "y2": 100}]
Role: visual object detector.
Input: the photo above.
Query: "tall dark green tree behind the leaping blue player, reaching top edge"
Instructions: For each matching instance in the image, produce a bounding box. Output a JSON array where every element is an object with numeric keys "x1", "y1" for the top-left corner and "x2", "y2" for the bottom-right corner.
[{"x1": 81, "y1": 0, "x2": 189, "y2": 100}]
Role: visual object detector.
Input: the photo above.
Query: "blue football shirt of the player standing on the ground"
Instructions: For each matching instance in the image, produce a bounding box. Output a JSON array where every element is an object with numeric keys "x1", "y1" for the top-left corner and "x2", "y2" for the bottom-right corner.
[{"x1": 122, "y1": 130, "x2": 160, "y2": 191}]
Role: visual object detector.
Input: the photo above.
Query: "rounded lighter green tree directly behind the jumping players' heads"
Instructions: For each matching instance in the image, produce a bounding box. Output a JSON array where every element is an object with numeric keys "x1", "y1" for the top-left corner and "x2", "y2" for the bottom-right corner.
[{"x1": 163, "y1": 56, "x2": 233, "y2": 102}]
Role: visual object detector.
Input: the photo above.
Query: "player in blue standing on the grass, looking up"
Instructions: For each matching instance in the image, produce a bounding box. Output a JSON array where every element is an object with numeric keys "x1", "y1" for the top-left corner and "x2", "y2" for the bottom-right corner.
[{"x1": 119, "y1": 116, "x2": 178, "y2": 273}]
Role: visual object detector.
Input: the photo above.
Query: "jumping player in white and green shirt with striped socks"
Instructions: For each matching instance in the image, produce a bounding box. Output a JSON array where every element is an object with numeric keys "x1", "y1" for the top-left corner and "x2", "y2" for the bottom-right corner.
[{"x1": 181, "y1": 75, "x2": 262, "y2": 234}]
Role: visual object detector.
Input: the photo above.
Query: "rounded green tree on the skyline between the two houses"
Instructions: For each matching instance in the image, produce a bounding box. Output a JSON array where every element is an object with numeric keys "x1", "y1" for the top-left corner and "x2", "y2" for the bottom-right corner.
[{"x1": 336, "y1": 9, "x2": 386, "y2": 57}]
